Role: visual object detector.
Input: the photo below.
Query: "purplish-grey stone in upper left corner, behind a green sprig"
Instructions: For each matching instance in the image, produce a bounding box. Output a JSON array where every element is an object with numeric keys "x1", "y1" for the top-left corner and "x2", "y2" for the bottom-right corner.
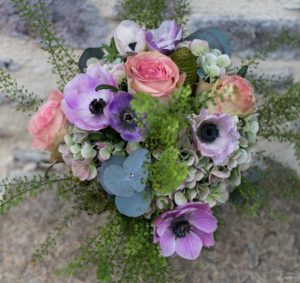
[{"x1": 0, "y1": 0, "x2": 111, "y2": 48}]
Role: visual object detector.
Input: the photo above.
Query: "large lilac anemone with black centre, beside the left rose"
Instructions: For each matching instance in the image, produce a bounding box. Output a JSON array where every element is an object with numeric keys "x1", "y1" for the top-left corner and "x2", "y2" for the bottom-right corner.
[{"x1": 61, "y1": 66, "x2": 116, "y2": 131}]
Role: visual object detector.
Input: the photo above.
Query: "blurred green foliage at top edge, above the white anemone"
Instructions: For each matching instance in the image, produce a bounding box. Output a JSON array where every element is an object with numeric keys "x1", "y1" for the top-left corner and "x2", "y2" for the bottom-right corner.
[{"x1": 120, "y1": 0, "x2": 190, "y2": 29}]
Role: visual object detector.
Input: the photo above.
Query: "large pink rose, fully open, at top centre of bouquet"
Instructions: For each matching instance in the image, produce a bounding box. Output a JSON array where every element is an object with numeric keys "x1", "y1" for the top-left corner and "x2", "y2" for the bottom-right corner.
[{"x1": 125, "y1": 51, "x2": 185, "y2": 97}]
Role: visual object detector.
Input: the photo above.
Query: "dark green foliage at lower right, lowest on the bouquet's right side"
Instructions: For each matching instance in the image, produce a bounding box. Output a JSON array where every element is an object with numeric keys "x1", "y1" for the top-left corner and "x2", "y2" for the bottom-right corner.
[{"x1": 230, "y1": 158, "x2": 300, "y2": 217}]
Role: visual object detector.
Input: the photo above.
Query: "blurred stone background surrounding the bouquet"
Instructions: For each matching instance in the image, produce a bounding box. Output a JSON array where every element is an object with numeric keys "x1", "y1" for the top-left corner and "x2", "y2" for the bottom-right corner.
[{"x1": 0, "y1": 0, "x2": 300, "y2": 283}]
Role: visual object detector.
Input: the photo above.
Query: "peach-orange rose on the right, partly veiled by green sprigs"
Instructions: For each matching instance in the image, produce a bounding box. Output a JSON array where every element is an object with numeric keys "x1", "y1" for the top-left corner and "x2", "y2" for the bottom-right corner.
[{"x1": 208, "y1": 75, "x2": 256, "y2": 116}]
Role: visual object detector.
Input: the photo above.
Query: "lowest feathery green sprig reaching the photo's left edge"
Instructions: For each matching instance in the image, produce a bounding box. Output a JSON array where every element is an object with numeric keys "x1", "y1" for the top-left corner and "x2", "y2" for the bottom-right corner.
[{"x1": 0, "y1": 175, "x2": 75, "y2": 215}]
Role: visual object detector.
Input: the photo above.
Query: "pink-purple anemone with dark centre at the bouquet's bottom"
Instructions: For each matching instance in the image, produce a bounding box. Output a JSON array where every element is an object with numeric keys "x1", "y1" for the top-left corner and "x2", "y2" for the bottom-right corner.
[{"x1": 154, "y1": 202, "x2": 217, "y2": 260}]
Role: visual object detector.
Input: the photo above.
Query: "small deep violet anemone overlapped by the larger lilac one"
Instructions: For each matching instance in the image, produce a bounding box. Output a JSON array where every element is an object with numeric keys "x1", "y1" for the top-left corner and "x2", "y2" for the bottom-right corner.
[{"x1": 107, "y1": 91, "x2": 142, "y2": 142}]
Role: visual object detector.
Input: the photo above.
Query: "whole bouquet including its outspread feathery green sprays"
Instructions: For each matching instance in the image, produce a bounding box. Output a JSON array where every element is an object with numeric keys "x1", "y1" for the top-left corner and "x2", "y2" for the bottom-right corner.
[{"x1": 0, "y1": 0, "x2": 300, "y2": 283}]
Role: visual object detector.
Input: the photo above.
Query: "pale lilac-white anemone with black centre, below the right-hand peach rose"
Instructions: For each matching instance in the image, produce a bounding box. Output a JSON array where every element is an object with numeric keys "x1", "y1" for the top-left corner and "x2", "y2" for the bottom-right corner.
[{"x1": 191, "y1": 109, "x2": 240, "y2": 165}]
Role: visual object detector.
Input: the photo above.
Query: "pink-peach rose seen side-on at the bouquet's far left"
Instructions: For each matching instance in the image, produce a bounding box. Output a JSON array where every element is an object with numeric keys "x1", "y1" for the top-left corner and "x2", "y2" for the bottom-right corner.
[{"x1": 28, "y1": 90, "x2": 66, "y2": 150}]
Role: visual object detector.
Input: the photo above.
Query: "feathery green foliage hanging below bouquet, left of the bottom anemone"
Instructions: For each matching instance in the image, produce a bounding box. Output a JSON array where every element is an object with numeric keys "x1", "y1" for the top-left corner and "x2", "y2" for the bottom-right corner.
[{"x1": 59, "y1": 215, "x2": 175, "y2": 283}]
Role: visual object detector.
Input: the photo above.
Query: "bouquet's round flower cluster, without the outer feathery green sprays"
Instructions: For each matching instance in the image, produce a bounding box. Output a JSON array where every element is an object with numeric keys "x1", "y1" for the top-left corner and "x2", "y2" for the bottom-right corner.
[{"x1": 29, "y1": 20, "x2": 259, "y2": 260}]
